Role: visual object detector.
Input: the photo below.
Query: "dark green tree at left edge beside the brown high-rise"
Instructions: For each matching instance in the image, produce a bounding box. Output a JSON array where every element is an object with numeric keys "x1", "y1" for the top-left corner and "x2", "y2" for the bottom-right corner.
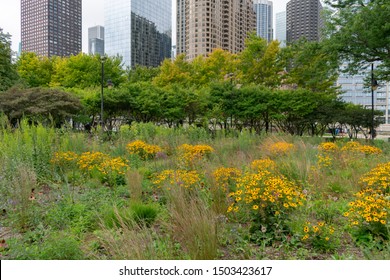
[{"x1": 0, "y1": 27, "x2": 18, "y2": 91}]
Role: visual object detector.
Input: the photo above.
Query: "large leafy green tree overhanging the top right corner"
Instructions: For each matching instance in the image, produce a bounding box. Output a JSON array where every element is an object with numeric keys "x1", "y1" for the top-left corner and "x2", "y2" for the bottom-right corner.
[{"x1": 328, "y1": 0, "x2": 390, "y2": 80}]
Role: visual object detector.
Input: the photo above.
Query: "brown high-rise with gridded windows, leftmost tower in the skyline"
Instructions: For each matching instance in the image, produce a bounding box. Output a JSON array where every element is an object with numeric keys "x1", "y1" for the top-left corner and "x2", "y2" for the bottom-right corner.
[{"x1": 21, "y1": 0, "x2": 82, "y2": 57}]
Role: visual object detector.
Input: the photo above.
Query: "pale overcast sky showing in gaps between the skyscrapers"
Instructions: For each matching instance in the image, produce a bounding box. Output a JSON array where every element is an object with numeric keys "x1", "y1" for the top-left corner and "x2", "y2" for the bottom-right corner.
[{"x1": 0, "y1": 0, "x2": 289, "y2": 52}]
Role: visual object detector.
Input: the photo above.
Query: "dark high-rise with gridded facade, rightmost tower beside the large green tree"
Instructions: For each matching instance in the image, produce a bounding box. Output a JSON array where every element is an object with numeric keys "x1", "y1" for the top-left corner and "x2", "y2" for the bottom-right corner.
[{"x1": 286, "y1": 0, "x2": 323, "y2": 42}]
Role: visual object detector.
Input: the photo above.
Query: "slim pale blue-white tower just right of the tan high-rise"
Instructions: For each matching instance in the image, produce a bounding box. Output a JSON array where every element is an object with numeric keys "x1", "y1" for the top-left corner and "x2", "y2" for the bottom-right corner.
[{"x1": 254, "y1": 0, "x2": 274, "y2": 42}]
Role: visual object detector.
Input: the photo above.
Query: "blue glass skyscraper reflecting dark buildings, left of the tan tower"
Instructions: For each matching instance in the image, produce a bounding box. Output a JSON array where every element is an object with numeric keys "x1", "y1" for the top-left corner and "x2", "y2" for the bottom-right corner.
[{"x1": 104, "y1": 0, "x2": 172, "y2": 67}]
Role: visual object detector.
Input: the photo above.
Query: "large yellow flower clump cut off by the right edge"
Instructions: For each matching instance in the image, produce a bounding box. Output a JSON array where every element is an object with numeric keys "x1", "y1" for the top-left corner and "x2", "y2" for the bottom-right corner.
[{"x1": 344, "y1": 162, "x2": 390, "y2": 235}]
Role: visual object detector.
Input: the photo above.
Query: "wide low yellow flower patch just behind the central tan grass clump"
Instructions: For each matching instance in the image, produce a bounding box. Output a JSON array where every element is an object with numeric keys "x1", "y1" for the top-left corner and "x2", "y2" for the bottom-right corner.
[{"x1": 153, "y1": 169, "x2": 200, "y2": 190}]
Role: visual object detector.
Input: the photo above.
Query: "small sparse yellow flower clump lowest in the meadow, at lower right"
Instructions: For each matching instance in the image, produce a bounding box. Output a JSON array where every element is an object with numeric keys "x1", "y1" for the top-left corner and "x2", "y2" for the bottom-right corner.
[{"x1": 301, "y1": 221, "x2": 338, "y2": 251}]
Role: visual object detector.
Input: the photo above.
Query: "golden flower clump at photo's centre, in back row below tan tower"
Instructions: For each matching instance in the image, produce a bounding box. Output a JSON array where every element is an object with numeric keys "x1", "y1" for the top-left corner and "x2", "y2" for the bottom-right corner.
[{"x1": 177, "y1": 144, "x2": 214, "y2": 166}]
